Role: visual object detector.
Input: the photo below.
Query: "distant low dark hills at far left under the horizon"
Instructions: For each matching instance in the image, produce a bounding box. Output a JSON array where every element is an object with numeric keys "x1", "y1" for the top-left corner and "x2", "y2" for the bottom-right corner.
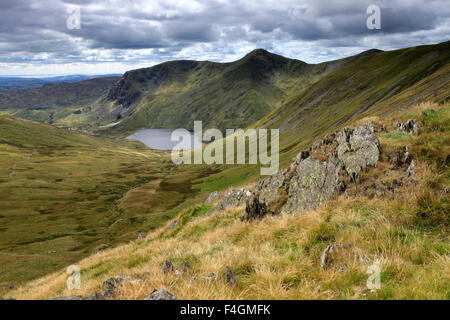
[{"x1": 0, "y1": 77, "x2": 120, "y2": 123}]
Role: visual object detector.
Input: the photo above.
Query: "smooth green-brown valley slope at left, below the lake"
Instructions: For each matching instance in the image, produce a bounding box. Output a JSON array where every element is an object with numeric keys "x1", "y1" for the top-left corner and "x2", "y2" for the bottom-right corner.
[{"x1": 0, "y1": 116, "x2": 225, "y2": 292}]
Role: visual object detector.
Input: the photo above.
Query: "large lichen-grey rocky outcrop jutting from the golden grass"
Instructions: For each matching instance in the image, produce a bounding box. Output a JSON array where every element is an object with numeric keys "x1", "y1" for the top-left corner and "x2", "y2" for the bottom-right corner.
[{"x1": 237, "y1": 122, "x2": 385, "y2": 221}]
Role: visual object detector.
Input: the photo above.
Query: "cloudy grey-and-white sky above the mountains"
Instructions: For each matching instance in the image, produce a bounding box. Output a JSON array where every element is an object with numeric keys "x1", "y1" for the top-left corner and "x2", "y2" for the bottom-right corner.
[{"x1": 0, "y1": 0, "x2": 450, "y2": 75}]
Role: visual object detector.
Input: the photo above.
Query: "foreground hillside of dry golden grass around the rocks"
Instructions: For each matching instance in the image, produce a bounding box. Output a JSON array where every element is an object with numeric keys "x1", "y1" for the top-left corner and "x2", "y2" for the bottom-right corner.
[{"x1": 8, "y1": 103, "x2": 450, "y2": 299}]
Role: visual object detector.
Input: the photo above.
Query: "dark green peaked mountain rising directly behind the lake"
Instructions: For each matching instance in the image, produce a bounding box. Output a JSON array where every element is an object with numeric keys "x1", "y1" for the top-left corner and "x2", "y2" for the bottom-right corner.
[{"x1": 89, "y1": 49, "x2": 354, "y2": 134}]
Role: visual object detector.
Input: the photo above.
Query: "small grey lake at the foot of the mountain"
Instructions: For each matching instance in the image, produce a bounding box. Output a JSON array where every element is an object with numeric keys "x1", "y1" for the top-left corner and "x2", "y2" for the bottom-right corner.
[{"x1": 127, "y1": 129, "x2": 202, "y2": 150}]
